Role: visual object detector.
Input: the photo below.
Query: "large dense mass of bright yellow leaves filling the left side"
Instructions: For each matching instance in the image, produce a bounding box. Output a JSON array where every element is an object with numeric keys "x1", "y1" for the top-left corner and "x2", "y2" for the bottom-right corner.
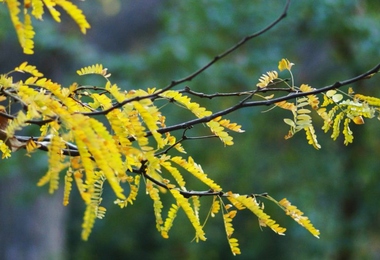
[{"x1": 0, "y1": 62, "x2": 243, "y2": 246}]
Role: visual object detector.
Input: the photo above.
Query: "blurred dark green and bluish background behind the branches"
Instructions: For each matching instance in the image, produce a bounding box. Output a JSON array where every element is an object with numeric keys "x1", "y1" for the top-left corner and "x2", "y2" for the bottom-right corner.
[{"x1": 0, "y1": 0, "x2": 380, "y2": 260}]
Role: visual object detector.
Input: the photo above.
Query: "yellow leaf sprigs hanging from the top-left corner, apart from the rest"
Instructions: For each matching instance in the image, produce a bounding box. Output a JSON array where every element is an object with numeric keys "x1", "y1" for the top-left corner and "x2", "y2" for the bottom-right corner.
[{"x1": 0, "y1": 0, "x2": 90, "y2": 54}]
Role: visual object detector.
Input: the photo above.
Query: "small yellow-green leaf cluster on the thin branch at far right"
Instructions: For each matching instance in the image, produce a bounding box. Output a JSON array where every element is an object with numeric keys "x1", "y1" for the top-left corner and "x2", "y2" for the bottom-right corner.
[{"x1": 257, "y1": 59, "x2": 380, "y2": 149}]
